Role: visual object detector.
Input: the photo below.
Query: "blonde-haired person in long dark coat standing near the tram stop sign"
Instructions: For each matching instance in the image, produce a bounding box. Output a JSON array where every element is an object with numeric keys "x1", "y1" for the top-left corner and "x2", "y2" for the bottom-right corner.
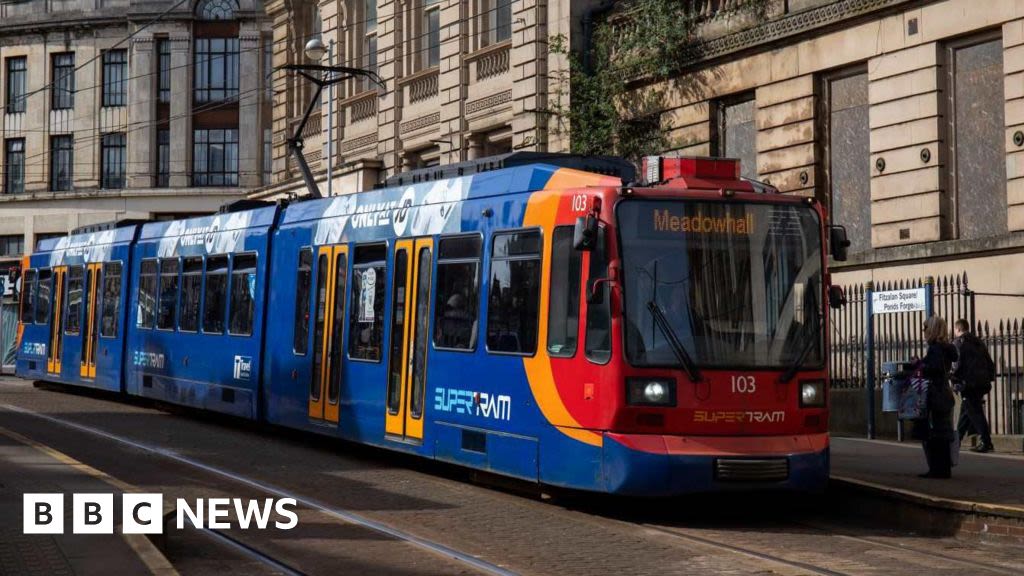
[{"x1": 911, "y1": 316, "x2": 956, "y2": 479}]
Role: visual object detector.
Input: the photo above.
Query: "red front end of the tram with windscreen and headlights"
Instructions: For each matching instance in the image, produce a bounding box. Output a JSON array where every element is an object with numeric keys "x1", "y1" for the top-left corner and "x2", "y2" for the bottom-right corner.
[{"x1": 605, "y1": 159, "x2": 843, "y2": 494}]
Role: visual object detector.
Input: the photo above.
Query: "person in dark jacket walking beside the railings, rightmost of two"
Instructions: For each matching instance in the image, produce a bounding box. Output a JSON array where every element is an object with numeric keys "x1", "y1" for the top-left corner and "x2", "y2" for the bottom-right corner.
[{"x1": 950, "y1": 319, "x2": 992, "y2": 452}]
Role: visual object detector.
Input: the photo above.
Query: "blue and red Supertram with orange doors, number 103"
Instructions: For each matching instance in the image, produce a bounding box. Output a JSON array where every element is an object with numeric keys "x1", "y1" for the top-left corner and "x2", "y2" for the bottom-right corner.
[{"x1": 16, "y1": 153, "x2": 848, "y2": 496}]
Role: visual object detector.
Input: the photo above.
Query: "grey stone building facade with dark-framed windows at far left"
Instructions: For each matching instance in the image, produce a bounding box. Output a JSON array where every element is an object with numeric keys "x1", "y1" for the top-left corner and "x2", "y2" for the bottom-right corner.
[{"x1": 0, "y1": 0, "x2": 272, "y2": 266}]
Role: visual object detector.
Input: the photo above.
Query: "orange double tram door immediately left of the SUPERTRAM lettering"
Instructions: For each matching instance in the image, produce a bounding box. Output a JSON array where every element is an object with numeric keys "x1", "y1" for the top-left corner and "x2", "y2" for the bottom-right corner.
[{"x1": 384, "y1": 238, "x2": 433, "y2": 442}]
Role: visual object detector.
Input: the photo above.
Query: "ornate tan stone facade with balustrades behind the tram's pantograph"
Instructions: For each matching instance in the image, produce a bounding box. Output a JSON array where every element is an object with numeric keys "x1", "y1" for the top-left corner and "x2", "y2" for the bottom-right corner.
[{"x1": 252, "y1": 0, "x2": 600, "y2": 198}]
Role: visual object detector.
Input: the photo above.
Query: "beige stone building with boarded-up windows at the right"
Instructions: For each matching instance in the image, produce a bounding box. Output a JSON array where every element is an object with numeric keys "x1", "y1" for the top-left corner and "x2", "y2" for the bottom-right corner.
[{"x1": 638, "y1": 0, "x2": 1024, "y2": 319}]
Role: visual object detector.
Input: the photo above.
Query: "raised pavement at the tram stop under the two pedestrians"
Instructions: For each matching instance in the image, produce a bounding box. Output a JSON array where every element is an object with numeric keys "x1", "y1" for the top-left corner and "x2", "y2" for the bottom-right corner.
[{"x1": 831, "y1": 437, "x2": 1024, "y2": 510}]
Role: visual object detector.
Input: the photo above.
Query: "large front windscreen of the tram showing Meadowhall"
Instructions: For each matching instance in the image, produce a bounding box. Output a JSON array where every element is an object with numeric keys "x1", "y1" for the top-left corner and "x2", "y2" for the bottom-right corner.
[{"x1": 617, "y1": 199, "x2": 822, "y2": 369}]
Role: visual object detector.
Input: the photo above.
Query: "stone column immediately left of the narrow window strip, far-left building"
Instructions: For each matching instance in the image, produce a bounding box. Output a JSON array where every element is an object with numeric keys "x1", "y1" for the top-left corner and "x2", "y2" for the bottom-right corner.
[{"x1": 128, "y1": 35, "x2": 157, "y2": 188}]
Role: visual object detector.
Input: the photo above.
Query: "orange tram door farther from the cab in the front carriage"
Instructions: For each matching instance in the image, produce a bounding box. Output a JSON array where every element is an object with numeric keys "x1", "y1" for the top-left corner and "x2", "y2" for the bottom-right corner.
[{"x1": 309, "y1": 246, "x2": 348, "y2": 423}]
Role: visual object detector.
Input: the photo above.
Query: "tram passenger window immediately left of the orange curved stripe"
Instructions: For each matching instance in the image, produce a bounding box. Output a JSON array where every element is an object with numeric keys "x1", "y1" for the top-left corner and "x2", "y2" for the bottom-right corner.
[{"x1": 487, "y1": 231, "x2": 542, "y2": 355}]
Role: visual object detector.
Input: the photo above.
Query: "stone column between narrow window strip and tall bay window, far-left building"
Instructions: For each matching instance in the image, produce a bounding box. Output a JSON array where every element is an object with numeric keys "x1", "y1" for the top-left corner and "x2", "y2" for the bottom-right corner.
[{"x1": 170, "y1": 32, "x2": 193, "y2": 188}]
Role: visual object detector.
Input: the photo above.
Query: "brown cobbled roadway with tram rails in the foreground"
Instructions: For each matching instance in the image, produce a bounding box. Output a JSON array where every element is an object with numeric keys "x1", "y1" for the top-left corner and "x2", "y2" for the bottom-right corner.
[{"x1": 0, "y1": 380, "x2": 1024, "y2": 576}]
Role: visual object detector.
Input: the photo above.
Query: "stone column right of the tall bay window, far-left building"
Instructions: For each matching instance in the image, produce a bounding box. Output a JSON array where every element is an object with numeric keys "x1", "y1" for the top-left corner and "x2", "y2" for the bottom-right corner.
[{"x1": 239, "y1": 22, "x2": 263, "y2": 188}]
